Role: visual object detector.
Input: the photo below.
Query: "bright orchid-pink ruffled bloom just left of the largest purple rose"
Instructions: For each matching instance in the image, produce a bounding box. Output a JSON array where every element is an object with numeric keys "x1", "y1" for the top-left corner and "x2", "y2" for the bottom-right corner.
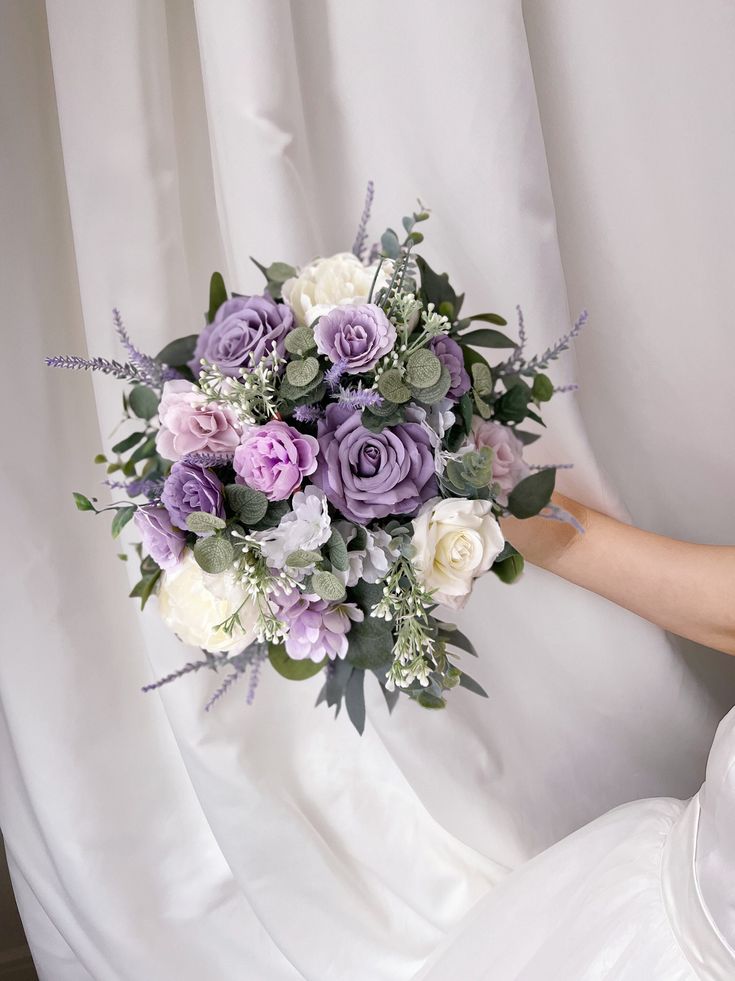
[{"x1": 233, "y1": 421, "x2": 319, "y2": 501}]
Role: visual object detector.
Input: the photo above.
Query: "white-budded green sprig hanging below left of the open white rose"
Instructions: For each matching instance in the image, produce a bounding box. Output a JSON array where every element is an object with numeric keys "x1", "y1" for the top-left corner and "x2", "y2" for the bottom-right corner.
[{"x1": 372, "y1": 555, "x2": 437, "y2": 691}]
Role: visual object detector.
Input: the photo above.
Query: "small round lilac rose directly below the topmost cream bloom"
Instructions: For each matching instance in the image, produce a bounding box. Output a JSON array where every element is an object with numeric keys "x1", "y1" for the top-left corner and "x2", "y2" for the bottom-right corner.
[{"x1": 314, "y1": 303, "x2": 396, "y2": 374}]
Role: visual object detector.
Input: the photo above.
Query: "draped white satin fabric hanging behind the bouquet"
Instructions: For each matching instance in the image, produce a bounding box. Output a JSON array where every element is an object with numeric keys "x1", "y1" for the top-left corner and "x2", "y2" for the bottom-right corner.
[{"x1": 0, "y1": 0, "x2": 735, "y2": 981}]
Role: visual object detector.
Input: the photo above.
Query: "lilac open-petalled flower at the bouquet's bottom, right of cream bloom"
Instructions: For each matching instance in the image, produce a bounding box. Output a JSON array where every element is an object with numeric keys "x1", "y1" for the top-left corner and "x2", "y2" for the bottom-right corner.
[{"x1": 271, "y1": 589, "x2": 365, "y2": 663}]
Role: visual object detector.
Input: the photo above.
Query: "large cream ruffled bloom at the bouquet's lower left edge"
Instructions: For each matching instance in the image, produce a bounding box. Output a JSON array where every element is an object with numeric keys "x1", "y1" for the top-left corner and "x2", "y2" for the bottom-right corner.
[{"x1": 158, "y1": 549, "x2": 258, "y2": 654}]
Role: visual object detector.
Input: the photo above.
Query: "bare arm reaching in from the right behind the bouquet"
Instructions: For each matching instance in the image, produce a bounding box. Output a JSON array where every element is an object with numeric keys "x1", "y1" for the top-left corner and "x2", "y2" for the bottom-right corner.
[{"x1": 502, "y1": 494, "x2": 735, "y2": 654}]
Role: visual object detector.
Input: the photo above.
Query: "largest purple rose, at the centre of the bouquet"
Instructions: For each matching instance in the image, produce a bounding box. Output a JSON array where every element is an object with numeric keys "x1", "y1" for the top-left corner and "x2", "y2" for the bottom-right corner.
[{"x1": 311, "y1": 405, "x2": 438, "y2": 525}]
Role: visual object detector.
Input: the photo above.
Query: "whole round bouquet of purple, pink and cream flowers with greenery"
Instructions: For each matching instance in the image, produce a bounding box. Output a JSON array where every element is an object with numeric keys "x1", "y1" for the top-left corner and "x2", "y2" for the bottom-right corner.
[{"x1": 47, "y1": 186, "x2": 584, "y2": 731}]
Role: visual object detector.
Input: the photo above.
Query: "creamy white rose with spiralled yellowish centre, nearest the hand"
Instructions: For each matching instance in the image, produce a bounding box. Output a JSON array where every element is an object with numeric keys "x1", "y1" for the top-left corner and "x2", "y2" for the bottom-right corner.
[{"x1": 413, "y1": 498, "x2": 505, "y2": 610}]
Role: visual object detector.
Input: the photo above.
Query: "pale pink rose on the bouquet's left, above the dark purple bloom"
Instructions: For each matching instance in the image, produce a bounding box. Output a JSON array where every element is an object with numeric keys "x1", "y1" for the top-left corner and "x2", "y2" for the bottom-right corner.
[{"x1": 156, "y1": 379, "x2": 241, "y2": 460}]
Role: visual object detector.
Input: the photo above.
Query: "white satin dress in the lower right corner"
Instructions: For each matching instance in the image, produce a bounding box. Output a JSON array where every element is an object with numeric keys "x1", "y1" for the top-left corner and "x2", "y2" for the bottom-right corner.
[{"x1": 415, "y1": 709, "x2": 735, "y2": 981}]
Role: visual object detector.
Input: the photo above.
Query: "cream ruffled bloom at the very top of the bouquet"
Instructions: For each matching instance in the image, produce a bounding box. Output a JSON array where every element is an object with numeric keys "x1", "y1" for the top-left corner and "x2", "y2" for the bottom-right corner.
[{"x1": 282, "y1": 252, "x2": 393, "y2": 326}]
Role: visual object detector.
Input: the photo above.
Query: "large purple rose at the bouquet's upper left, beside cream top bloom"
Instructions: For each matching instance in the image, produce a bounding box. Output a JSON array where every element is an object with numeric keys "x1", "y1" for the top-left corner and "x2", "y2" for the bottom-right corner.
[{"x1": 189, "y1": 296, "x2": 293, "y2": 378}]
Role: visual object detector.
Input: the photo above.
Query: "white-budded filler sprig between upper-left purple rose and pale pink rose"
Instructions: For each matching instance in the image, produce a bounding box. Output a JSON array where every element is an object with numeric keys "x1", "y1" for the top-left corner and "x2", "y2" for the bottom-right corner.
[{"x1": 198, "y1": 345, "x2": 284, "y2": 426}]
